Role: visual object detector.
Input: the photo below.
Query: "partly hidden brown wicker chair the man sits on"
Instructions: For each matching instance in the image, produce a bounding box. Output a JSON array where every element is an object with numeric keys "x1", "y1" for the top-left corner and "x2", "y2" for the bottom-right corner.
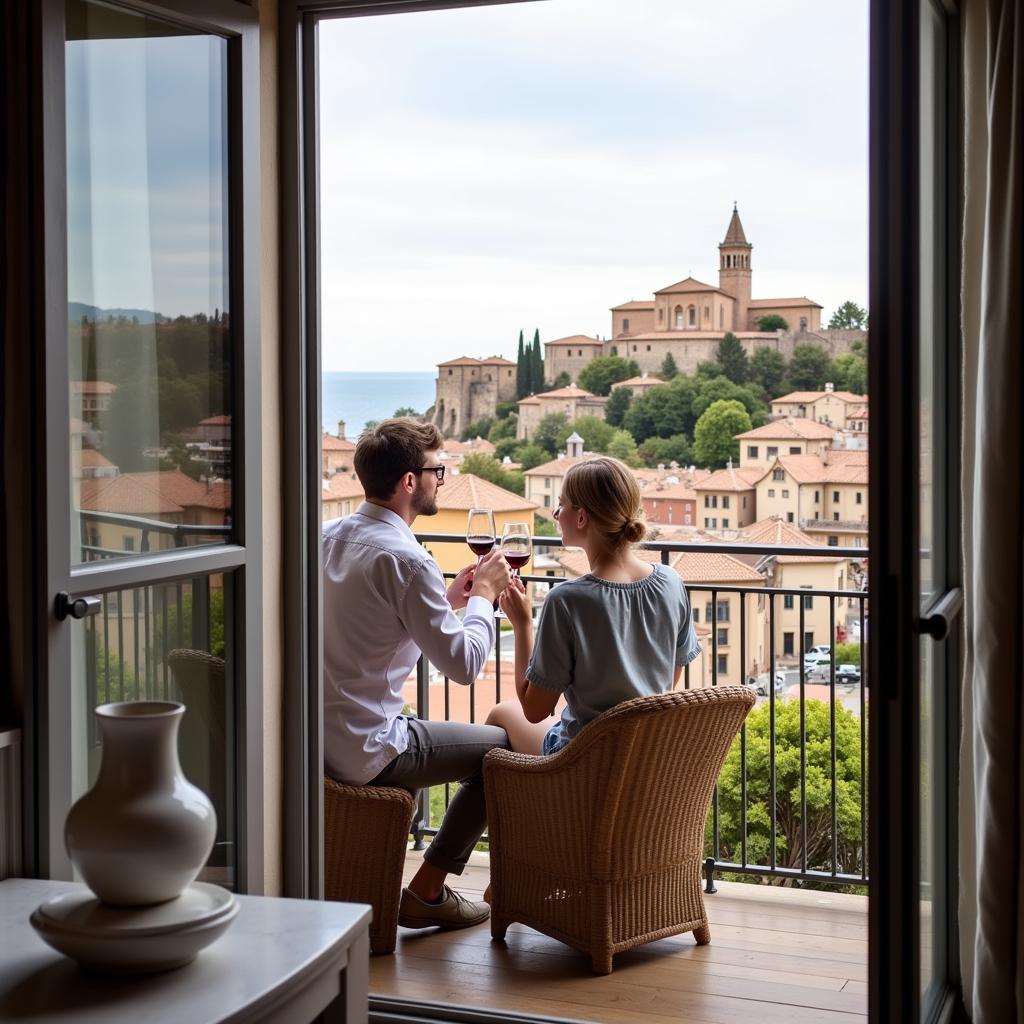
[{"x1": 324, "y1": 778, "x2": 416, "y2": 953}]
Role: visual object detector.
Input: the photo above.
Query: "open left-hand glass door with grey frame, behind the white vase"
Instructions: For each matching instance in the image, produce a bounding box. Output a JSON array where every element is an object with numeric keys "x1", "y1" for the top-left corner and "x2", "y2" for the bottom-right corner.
[{"x1": 39, "y1": 0, "x2": 261, "y2": 889}]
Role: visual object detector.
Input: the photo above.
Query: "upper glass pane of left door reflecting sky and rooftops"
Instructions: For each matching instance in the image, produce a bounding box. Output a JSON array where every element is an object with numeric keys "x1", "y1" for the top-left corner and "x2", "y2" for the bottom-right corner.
[{"x1": 66, "y1": 0, "x2": 232, "y2": 563}]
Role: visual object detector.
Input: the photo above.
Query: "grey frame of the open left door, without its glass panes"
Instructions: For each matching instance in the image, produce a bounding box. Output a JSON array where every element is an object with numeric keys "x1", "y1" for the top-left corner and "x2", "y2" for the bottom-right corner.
[{"x1": 20, "y1": 0, "x2": 263, "y2": 892}]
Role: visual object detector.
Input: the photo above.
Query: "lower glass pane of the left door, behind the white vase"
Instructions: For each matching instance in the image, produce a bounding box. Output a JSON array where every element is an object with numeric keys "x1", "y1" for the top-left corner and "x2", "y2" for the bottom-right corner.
[{"x1": 72, "y1": 574, "x2": 237, "y2": 886}]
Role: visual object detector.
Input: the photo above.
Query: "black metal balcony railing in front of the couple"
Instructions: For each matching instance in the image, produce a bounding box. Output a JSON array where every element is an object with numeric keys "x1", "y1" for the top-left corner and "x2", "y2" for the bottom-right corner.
[{"x1": 414, "y1": 534, "x2": 869, "y2": 892}]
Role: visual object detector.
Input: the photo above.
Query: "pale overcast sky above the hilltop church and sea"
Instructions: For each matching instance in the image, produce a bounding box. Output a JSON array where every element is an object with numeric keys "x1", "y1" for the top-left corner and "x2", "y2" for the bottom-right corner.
[{"x1": 321, "y1": 0, "x2": 867, "y2": 371}]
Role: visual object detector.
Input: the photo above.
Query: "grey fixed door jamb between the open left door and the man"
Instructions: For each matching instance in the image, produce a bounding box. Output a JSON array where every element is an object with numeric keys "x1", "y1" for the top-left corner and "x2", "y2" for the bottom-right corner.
[{"x1": 279, "y1": 0, "x2": 536, "y2": 898}]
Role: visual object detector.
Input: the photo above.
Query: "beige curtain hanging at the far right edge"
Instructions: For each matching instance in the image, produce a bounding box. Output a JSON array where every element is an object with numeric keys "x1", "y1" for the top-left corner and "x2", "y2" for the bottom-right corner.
[{"x1": 959, "y1": 0, "x2": 1024, "y2": 1024}]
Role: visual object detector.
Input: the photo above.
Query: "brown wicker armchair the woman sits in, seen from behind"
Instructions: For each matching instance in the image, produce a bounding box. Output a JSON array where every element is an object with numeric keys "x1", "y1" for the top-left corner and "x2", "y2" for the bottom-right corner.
[{"x1": 483, "y1": 686, "x2": 755, "y2": 974}]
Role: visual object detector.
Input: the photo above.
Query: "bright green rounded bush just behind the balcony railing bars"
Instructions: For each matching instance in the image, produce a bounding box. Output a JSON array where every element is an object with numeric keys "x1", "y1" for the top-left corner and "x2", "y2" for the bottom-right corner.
[{"x1": 705, "y1": 700, "x2": 866, "y2": 885}]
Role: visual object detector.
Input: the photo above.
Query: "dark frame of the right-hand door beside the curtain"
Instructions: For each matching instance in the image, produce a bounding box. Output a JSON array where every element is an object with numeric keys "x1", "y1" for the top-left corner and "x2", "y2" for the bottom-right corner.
[{"x1": 867, "y1": 0, "x2": 963, "y2": 1024}]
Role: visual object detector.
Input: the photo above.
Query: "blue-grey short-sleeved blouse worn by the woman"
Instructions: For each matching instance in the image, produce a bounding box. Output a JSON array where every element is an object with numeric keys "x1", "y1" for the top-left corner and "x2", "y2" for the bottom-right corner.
[{"x1": 526, "y1": 563, "x2": 700, "y2": 754}]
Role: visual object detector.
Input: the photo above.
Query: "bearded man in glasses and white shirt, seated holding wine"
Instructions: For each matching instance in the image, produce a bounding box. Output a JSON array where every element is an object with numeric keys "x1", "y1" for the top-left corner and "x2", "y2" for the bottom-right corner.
[{"x1": 324, "y1": 420, "x2": 511, "y2": 929}]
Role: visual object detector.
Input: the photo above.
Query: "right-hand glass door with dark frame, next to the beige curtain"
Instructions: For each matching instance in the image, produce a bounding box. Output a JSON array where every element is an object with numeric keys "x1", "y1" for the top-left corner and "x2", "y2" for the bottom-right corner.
[{"x1": 868, "y1": 0, "x2": 963, "y2": 1022}]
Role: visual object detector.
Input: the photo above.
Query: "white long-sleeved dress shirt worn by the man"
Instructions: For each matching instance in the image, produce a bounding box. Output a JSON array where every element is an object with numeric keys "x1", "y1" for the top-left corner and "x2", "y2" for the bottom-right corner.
[{"x1": 324, "y1": 502, "x2": 495, "y2": 785}]
